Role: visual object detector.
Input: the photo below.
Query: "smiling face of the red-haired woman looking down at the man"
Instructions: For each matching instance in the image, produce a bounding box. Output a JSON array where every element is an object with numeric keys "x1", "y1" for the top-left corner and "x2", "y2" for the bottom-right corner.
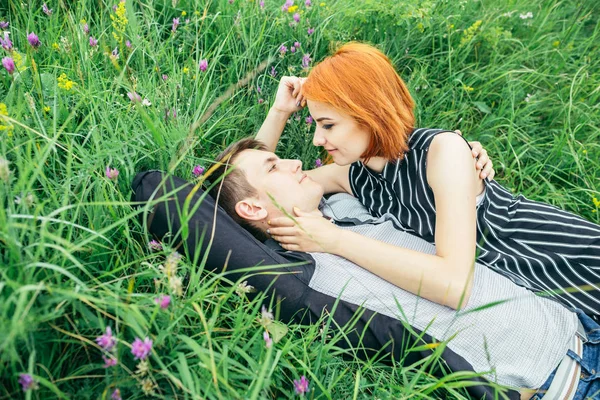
[{"x1": 307, "y1": 100, "x2": 371, "y2": 165}]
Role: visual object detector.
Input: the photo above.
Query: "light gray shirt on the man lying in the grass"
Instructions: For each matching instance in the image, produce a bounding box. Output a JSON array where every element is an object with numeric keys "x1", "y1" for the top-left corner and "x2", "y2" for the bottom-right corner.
[{"x1": 310, "y1": 194, "x2": 577, "y2": 388}]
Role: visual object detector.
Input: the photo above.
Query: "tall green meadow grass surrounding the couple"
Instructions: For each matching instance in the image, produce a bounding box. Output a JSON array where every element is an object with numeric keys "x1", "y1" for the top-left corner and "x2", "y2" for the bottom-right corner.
[{"x1": 0, "y1": 0, "x2": 600, "y2": 399}]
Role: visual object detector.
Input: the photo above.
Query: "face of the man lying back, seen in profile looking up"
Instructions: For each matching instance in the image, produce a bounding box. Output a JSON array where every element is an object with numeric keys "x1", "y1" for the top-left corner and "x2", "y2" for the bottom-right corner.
[{"x1": 235, "y1": 150, "x2": 323, "y2": 218}]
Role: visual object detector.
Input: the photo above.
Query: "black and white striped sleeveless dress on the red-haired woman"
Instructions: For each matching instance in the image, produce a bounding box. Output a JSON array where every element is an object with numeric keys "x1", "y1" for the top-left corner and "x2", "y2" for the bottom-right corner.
[{"x1": 349, "y1": 128, "x2": 600, "y2": 317}]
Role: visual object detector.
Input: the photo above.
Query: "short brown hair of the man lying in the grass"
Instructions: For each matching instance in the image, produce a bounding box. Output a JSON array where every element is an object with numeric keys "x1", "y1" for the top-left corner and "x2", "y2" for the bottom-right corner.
[{"x1": 208, "y1": 138, "x2": 269, "y2": 242}]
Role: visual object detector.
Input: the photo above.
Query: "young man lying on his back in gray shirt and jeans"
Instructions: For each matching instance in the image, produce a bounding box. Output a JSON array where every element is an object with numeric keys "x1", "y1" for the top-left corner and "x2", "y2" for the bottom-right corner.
[{"x1": 198, "y1": 139, "x2": 600, "y2": 399}]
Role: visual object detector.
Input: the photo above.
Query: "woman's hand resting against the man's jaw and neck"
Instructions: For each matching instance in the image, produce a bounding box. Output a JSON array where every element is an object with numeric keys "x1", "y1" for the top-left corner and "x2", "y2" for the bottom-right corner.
[{"x1": 267, "y1": 207, "x2": 341, "y2": 254}]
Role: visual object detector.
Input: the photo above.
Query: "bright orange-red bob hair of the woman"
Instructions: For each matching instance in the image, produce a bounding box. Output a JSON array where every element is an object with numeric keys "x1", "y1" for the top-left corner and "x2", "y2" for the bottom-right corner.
[{"x1": 303, "y1": 42, "x2": 415, "y2": 160}]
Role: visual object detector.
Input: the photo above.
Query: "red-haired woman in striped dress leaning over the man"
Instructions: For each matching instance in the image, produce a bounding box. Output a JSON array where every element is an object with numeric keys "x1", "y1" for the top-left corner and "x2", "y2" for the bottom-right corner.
[{"x1": 257, "y1": 43, "x2": 600, "y2": 316}]
